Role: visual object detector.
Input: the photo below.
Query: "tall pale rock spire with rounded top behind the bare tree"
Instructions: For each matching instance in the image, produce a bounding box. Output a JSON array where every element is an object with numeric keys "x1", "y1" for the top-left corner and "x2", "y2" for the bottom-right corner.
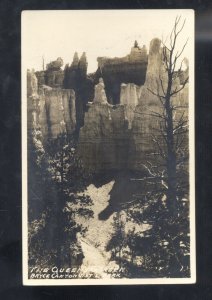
[{"x1": 129, "y1": 39, "x2": 188, "y2": 170}]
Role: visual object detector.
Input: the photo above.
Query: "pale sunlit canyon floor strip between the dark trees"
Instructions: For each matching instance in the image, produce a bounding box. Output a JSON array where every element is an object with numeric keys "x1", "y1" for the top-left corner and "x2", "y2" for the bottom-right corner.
[{"x1": 78, "y1": 181, "x2": 117, "y2": 278}]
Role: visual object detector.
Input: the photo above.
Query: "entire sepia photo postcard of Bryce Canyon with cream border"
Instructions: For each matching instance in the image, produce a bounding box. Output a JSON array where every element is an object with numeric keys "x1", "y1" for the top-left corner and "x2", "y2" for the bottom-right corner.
[{"x1": 22, "y1": 9, "x2": 196, "y2": 285}]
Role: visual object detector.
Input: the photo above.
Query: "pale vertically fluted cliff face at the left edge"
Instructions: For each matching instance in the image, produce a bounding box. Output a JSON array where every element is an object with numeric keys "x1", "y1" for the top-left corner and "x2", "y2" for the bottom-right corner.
[{"x1": 27, "y1": 71, "x2": 76, "y2": 140}]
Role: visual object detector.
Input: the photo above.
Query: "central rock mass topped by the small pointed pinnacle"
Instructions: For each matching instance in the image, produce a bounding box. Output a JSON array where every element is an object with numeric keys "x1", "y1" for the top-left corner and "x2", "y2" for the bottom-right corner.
[{"x1": 78, "y1": 80, "x2": 129, "y2": 171}]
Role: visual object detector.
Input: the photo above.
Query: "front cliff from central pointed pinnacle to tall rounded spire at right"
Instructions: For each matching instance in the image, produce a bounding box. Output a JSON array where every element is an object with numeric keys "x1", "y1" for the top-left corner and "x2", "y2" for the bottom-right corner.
[{"x1": 78, "y1": 39, "x2": 188, "y2": 171}]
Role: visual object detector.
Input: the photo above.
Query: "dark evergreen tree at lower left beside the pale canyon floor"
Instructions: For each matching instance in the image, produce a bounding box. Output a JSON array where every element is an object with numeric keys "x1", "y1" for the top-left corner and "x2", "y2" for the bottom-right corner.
[{"x1": 30, "y1": 133, "x2": 93, "y2": 267}]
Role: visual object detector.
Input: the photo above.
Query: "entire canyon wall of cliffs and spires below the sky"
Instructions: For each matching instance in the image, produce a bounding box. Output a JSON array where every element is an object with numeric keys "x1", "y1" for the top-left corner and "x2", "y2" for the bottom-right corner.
[{"x1": 27, "y1": 39, "x2": 189, "y2": 171}]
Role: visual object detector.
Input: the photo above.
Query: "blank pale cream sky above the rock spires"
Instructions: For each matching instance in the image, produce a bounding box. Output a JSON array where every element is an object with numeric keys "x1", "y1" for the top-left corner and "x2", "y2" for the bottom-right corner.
[{"x1": 22, "y1": 9, "x2": 194, "y2": 73}]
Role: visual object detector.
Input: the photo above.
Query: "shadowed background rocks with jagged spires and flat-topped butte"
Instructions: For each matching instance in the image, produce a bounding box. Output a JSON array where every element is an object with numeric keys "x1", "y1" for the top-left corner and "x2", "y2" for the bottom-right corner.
[{"x1": 36, "y1": 42, "x2": 148, "y2": 132}]
